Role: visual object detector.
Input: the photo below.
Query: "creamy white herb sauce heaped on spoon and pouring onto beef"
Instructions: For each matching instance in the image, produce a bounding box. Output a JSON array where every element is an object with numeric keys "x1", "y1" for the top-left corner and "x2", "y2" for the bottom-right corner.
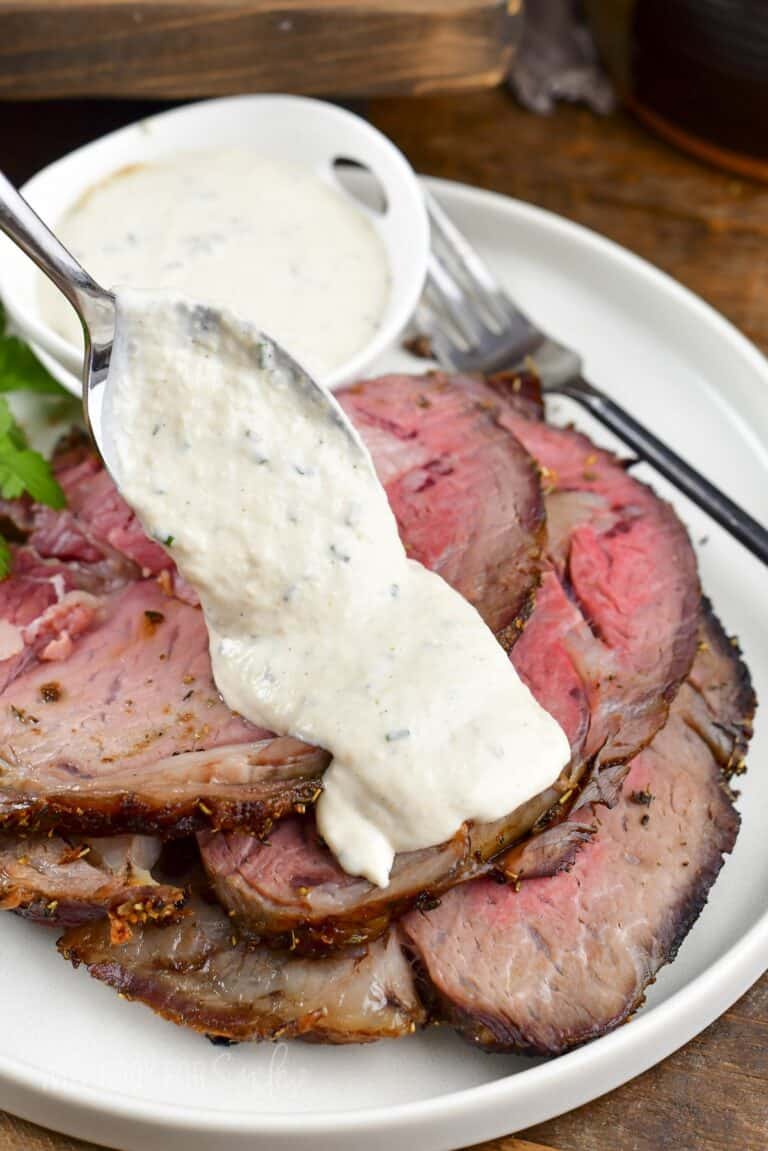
[{"x1": 106, "y1": 291, "x2": 569, "y2": 886}]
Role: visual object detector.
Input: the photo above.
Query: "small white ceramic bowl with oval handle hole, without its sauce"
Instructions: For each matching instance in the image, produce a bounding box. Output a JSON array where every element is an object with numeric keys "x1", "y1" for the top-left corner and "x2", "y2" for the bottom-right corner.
[{"x1": 0, "y1": 96, "x2": 429, "y2": 394}]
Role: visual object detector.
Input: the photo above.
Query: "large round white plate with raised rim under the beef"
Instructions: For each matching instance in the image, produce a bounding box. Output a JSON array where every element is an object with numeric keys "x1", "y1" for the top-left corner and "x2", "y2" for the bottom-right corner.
[{"x1": 0, "y1": 182, "x2": 768, "y2": 1151}]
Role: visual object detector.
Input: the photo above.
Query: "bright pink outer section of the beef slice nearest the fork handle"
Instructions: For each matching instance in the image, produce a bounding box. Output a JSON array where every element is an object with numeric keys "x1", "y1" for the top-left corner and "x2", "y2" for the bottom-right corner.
[{"x1": 499, "y1": 379, "x2": 700, "y2": 765}]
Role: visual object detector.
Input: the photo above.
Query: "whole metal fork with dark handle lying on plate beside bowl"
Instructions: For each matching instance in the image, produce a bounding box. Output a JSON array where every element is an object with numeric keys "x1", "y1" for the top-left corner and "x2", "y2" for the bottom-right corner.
[{"x1": 419, "y1": 192, "x2": 768, "y2": 563}]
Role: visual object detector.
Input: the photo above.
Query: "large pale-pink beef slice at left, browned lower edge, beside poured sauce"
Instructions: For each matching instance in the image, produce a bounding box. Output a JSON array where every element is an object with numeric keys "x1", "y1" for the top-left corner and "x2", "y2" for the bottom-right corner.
[{"x1": 0, "y1": 580, "x2": 328, "y2": 834}]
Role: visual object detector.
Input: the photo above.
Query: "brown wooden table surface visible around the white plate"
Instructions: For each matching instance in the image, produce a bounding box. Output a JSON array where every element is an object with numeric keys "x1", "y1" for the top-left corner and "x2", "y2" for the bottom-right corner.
[{"x1": 0, "y1": 91, "x2": 768, "y2": 1151}]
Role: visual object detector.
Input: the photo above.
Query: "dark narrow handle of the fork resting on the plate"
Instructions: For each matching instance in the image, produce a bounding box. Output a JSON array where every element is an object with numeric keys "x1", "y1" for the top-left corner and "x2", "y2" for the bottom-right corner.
[{"x1": 559, "y1": 379, "x2": 768, "y2": 564}]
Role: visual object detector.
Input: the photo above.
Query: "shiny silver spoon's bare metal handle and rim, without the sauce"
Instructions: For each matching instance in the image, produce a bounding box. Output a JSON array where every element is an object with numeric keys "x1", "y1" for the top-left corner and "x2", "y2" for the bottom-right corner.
[{"x1": 0, "y1": 171, "x2": 115, "y2": 467}]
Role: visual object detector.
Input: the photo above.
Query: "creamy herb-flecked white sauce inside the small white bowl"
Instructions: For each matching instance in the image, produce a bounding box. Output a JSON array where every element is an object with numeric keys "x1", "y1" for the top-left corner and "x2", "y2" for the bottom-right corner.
[{"x1": 40, "y1": 148, "x2": 389, "y2": 376}]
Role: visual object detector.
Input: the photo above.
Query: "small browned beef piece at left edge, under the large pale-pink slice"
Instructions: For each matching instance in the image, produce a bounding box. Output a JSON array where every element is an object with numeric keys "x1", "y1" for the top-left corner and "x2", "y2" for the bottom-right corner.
[{"x1": 0, "y1": 836, "x2": 184, "y2": 943}]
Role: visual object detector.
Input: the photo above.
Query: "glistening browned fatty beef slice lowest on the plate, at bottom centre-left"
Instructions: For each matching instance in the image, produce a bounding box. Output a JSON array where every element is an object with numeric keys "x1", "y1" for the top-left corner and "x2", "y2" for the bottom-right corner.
[{"x1": 59, "y1": 899, "x2": 425, "y2": 1043}]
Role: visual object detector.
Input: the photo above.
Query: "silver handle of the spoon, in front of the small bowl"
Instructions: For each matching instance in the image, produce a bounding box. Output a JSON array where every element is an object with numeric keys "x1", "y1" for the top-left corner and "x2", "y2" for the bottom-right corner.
[{"x1": 0, "y1": 171, "x2": 113, "y2": 335}]
